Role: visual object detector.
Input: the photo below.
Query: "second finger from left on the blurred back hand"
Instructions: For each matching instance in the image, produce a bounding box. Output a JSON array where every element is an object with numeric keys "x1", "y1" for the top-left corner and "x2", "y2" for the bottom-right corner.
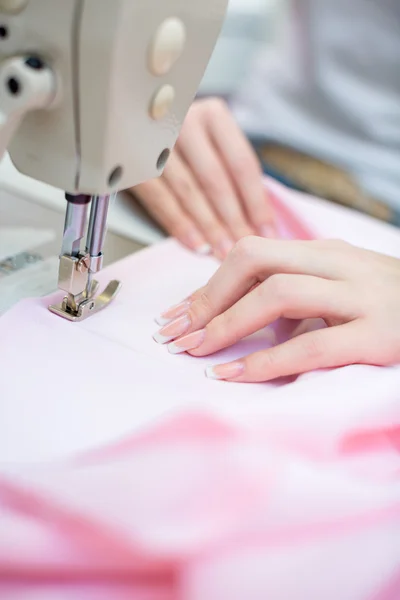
[{"x1": 163, "y1": 151, "x2": 232, "y2": 258}]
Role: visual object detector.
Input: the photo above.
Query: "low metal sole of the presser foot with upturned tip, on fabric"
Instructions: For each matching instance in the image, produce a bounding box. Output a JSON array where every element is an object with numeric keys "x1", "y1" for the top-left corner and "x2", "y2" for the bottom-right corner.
[{"x1": 49, "y1": 280, "x2": 122, "y2": 321}]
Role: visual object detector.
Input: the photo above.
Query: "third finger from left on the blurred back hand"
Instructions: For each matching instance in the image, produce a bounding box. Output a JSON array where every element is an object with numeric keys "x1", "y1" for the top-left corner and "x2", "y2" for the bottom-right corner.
[{"x1": 179, "y1": 108, "x2": 255, "y2": 247}]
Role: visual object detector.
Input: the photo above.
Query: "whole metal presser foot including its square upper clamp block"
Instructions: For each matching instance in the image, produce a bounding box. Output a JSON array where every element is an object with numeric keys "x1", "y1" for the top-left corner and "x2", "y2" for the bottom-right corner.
[{"x1": 49, "y1": 255, "x2": 121, "y2": 321}]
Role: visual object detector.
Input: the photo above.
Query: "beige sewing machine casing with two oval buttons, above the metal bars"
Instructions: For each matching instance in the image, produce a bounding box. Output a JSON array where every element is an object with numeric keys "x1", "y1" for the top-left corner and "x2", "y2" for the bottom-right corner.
[{"x1": 0, "y1": 0, "x2": 226, "y2": 194}]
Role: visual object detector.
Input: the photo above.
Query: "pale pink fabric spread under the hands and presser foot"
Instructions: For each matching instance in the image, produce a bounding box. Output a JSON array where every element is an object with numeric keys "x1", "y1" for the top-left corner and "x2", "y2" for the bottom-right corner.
[{"x1": 0, "y1": 182, "x2": 400, "y2": 600}]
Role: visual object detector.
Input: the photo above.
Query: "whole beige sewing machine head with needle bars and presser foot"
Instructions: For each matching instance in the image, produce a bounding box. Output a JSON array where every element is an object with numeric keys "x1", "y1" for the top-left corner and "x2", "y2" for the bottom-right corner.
[{"x1": 0, "y1": 0, "x2": 228, "y2": 321}]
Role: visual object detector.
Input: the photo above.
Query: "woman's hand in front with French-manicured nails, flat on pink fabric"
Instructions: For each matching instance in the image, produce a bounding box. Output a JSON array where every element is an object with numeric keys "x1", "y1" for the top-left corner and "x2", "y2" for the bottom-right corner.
[{"x1": 155, "y1": 237, "x2": 400, "y2": 382}]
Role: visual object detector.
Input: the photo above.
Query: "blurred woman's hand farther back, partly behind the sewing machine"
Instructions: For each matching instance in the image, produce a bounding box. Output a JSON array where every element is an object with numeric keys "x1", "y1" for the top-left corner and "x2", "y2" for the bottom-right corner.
[{"x1": 131, "y1": 98, "x2": 274, "y2": 258}]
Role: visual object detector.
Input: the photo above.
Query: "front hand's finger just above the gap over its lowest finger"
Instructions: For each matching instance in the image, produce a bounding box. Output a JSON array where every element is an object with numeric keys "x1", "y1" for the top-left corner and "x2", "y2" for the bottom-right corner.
[{"x1": 169, "y1": 275, "x2": 350, "y2": 356}]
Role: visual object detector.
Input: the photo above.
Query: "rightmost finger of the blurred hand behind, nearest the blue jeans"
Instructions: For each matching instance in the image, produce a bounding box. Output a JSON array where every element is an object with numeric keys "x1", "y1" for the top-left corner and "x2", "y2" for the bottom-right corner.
[{"x1": 202, "y1": 98, "x2": 275, "y2": 237}]
